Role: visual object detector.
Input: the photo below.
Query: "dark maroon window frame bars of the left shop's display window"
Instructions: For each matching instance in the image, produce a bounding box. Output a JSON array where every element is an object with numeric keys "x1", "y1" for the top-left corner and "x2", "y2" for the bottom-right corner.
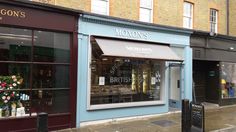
[{"x1": 0, "y1": 26, "x2": 73, "y2": 116}]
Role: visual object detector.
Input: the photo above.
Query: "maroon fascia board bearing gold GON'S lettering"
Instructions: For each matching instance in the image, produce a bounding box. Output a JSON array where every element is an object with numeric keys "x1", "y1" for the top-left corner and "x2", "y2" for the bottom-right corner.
[{"x1": 0, "y1": 4, "x2": 75, "y2": 31}]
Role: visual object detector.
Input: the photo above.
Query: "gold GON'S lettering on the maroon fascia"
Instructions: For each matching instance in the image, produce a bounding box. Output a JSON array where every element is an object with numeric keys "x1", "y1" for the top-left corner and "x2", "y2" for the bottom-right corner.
[{"x1": 0, "y1": 8, "x2": 26, "y2": 18}]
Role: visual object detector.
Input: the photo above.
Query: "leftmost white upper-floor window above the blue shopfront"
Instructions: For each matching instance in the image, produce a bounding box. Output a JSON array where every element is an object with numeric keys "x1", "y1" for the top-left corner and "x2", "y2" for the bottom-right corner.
[{"x1": 91, "y1": 0, "x2": 109, "y2": 15}]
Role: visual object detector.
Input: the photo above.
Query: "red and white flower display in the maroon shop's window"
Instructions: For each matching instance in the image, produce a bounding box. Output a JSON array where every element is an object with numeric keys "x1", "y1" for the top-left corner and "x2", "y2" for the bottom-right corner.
[{"x1": 0, "y1": 75, "x2": 23, "y2": 106}]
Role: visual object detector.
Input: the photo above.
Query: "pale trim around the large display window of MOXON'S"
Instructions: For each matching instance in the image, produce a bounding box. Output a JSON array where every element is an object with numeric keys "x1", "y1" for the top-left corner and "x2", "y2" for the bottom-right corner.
[{"x1": 87, "y1": 36, "x2": 168, "y2": 111}]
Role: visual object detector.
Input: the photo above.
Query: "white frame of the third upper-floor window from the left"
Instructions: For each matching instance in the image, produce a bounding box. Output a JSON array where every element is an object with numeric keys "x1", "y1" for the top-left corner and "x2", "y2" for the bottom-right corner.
[{"x1": 183, "y1": 1, "x2": 194, "y2": 29}]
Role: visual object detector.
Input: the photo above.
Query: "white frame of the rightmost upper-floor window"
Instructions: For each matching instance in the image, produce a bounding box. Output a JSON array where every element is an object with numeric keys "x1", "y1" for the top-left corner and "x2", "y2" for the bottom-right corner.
[{"x1": 209, "y1": 8, "x2": 218, "y2": 33}]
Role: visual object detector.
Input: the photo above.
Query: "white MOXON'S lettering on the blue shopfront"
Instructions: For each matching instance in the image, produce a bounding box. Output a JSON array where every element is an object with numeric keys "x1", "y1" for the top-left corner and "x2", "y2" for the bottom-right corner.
[{"x1": 115, "y1": 28, "x2": 148, "y2": 40}]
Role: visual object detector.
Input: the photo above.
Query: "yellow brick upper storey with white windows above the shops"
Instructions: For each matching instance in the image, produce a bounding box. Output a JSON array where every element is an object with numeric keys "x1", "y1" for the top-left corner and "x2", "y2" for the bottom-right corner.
[{"x1": 33, "y1": 0, "x2": 236, "y2": 36}]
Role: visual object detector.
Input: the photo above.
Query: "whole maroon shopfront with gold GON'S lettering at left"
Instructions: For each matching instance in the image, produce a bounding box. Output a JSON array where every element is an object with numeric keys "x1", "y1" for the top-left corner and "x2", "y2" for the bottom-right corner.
[{"x1": 0, "y1": 1, "x2": 78, "y2": 131}]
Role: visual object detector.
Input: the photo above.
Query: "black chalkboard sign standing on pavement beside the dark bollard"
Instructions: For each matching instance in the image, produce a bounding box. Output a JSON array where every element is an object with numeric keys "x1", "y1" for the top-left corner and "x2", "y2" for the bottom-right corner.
[{"x1": 190, "y1": 103, "x2": 205, "y2": 132}]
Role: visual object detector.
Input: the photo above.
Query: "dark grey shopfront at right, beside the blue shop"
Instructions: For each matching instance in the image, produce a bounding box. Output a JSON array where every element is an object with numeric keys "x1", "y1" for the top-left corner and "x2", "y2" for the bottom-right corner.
[{"x1": 191, "y1": 32, "x2": 236, "y2": 106}]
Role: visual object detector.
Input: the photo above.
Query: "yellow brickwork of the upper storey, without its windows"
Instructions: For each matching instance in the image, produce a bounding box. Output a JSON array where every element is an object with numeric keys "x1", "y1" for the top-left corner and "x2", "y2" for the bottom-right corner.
[{"x1": 31, "y1": 0, "x2": 232, "y2": 35}]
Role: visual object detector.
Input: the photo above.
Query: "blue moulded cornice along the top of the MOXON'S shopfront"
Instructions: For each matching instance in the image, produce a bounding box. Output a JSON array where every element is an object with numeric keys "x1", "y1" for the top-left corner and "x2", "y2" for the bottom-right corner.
[{"x1": 79, "y1": 13, "x2": 193, "y2": 36}]
